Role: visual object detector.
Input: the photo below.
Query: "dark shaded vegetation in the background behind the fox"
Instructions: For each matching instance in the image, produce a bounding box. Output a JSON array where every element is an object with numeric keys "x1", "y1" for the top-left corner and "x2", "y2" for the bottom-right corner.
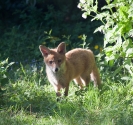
[{"x1": 0, "y1": 0, "x2": 105, "y2": 63}]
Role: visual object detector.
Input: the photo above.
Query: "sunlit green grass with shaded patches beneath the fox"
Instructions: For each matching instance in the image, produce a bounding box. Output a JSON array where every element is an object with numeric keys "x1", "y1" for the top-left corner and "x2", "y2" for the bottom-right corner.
[{"x1": 0, "y1": 65, "x2": 133, "y2": 125}]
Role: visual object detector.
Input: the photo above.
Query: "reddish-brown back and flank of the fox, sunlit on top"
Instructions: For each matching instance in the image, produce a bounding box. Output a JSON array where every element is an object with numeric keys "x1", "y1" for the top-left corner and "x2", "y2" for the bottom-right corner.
[{"x1": 66, "y1": 48, "x2": 95, "y2": 76}]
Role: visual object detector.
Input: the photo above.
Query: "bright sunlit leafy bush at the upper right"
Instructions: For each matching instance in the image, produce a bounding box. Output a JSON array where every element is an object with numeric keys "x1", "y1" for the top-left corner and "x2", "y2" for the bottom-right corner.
[{"x1": 78, "y1": 0, "x2": 133, "y2": 80}]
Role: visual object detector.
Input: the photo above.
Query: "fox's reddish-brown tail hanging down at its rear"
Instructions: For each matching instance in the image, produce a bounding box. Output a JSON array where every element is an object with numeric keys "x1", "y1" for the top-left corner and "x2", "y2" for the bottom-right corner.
[{"x1": 90, "y1": 65, "x2": 101, "y2": 88}]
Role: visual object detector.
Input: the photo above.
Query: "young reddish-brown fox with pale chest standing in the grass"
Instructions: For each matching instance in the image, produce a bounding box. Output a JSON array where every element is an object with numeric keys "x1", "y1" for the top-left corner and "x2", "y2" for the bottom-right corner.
[{"x1": 39, "y1": 42, "x2": 101, "y2": 97}]
